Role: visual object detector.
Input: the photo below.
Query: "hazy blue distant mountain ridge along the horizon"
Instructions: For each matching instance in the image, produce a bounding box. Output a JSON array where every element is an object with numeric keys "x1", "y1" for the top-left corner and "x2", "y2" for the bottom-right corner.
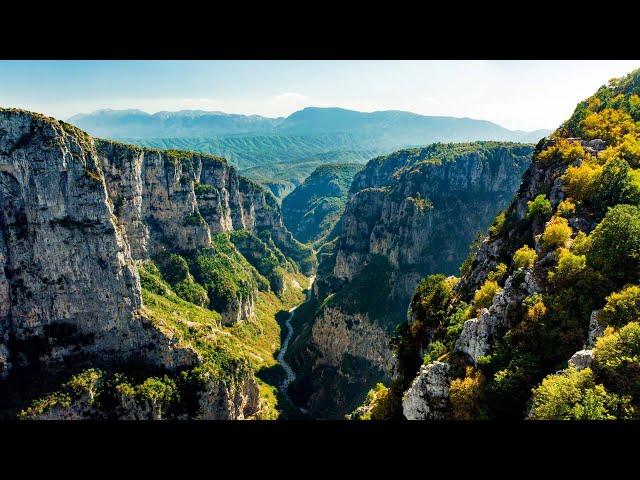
[{"x1": 68, "y1": 107, "x2": 550, "y2": 148}]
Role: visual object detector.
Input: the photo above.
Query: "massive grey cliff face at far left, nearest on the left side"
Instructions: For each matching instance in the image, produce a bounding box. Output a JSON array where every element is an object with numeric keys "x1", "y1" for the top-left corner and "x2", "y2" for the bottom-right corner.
[{"x1": 0, "y1": 110, "x2": 196, "y2": 376}]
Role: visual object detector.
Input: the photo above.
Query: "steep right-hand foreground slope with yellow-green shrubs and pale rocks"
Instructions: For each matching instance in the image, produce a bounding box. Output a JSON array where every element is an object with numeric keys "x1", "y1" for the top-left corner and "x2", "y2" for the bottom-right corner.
[{"x1": 354, "y1": 66, "x2": 640, "y2": 420}]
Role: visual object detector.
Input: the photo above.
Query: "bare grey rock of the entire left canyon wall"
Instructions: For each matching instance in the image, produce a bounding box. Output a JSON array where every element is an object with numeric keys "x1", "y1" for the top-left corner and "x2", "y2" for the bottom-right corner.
[{"x1": 0, "y1": 109, "x2": 313, "y2": 418}]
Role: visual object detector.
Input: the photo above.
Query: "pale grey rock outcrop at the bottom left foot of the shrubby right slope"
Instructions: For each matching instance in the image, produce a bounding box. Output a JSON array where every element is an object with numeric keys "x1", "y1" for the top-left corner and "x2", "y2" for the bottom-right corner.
[{"x1": 402, "y1": 362, "x2": 451, "y2": 420}]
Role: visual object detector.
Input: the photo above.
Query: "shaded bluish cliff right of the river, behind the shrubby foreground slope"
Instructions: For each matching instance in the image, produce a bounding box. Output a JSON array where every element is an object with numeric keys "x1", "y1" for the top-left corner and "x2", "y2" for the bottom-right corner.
[{"x1": 288, "y1": 142, "x2": 533, "y2": 416}]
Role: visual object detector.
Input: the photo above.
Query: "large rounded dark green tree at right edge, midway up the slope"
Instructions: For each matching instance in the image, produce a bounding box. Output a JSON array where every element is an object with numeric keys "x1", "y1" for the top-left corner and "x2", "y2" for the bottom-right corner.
[{"x1": 587, "y1": 205, "x2": 640, "y2": 286}]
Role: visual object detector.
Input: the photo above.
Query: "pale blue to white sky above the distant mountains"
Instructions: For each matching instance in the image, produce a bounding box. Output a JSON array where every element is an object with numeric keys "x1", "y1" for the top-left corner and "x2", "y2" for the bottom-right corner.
[{"x1": 0, "y1": 60, "x2": 640, "y2": 130}]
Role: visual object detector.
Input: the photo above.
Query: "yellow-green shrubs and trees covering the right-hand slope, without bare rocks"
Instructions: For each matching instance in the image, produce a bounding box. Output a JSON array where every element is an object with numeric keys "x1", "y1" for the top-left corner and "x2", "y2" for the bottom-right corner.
[{"x1": 360, "y1": 66, "x2": 640, "y2": 419}]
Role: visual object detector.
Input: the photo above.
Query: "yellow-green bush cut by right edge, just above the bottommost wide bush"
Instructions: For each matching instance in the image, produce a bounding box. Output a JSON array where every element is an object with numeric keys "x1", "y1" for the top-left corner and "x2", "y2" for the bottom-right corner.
[{"x1": 593, "y1": 322, "x2": 640, "y2": 402}]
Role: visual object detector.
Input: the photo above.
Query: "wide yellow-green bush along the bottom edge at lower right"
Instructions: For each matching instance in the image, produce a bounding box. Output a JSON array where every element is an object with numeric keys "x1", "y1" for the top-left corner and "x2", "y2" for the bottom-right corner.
[{"x1": 531, "y1": 367, "x2": 631, "y2": 420}]
